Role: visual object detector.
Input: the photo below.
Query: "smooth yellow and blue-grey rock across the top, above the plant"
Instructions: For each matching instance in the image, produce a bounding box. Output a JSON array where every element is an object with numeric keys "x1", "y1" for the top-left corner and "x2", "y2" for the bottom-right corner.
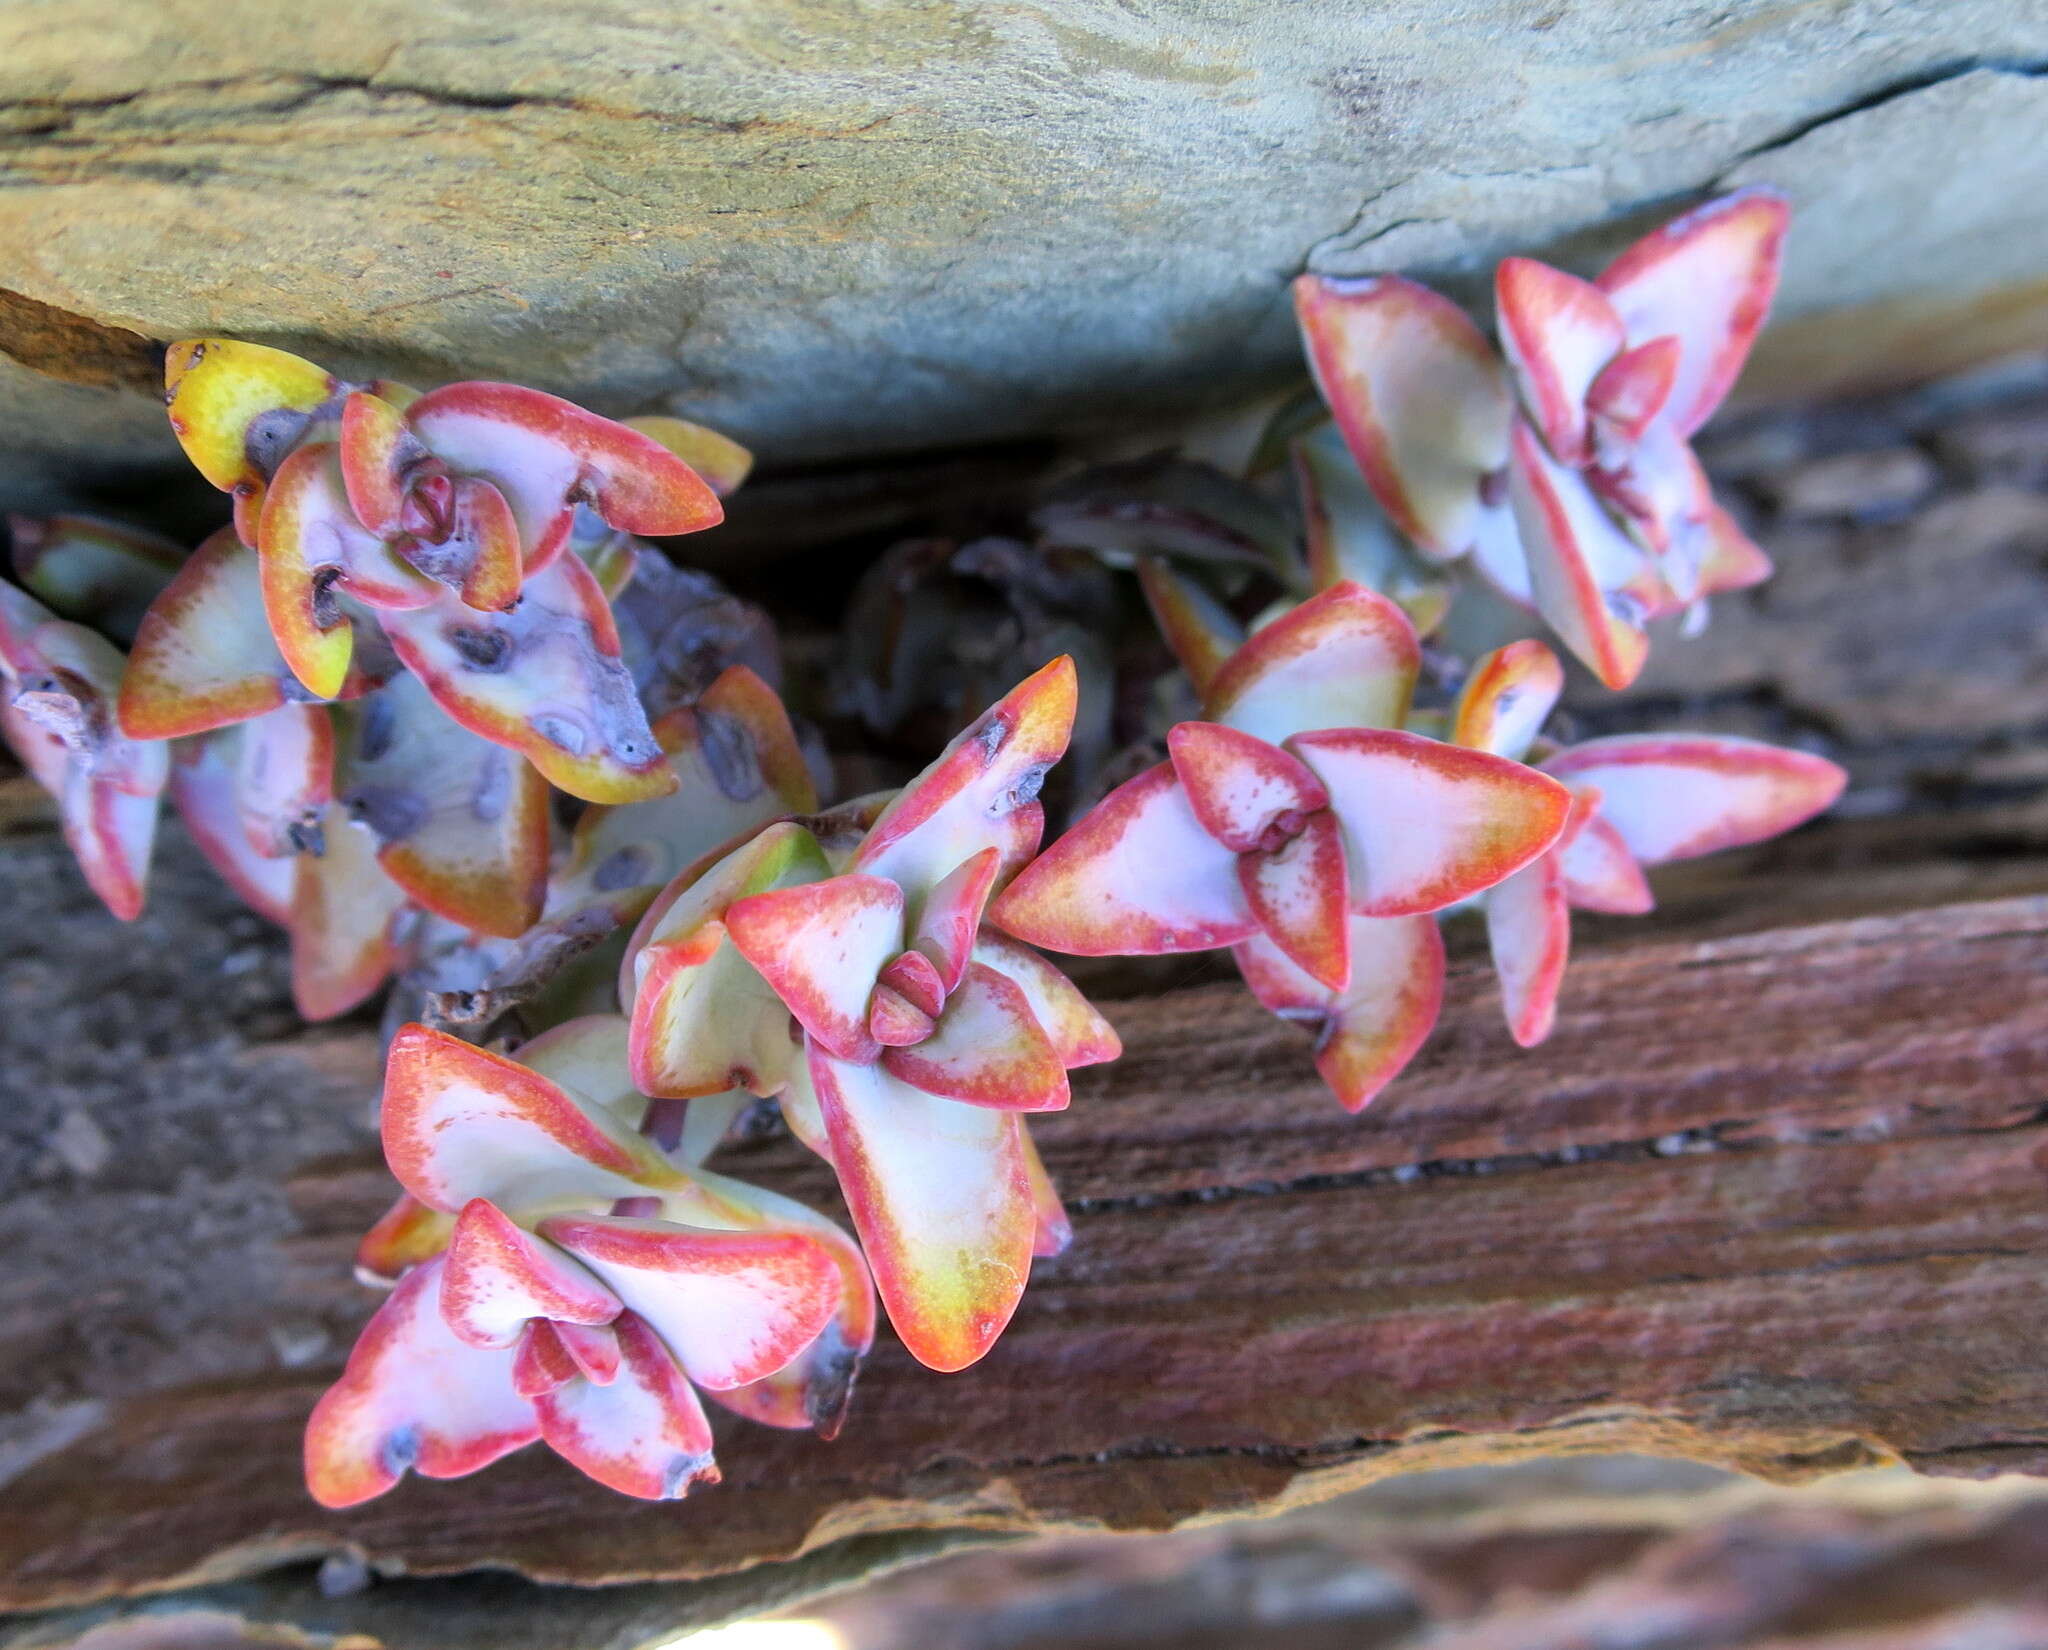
[{"x1": 0, "y1": 0, "x2": 2048, "y2": 506}]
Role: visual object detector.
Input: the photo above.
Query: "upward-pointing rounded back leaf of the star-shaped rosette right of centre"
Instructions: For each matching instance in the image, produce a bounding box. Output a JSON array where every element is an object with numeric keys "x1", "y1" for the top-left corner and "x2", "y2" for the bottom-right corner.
[{"x1": 1202, "y1": 583, "x2": 1421, "y2": 745}]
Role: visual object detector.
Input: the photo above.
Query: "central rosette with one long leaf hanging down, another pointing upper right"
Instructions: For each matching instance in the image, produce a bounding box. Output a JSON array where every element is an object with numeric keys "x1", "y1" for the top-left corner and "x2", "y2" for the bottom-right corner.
[{"x1": 623, "y1": 659, "x2": 1118, "y2": 1370}]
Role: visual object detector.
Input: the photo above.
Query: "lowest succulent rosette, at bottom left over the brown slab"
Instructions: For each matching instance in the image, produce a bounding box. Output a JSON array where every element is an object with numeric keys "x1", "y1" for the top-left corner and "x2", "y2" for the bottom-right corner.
[{"x1": 305, "y1": 1015, "x2": 874, "y2": 1507}]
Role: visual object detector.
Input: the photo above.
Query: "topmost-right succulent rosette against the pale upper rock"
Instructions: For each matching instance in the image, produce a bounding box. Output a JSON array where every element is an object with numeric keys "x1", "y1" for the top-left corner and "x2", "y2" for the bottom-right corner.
[{"x1": 1294, "y1": 188, "x2": 1786, "y2": 688}]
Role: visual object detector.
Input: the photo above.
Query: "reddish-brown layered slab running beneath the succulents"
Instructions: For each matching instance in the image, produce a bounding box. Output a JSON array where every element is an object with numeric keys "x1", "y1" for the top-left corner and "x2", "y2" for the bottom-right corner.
[{"x1": 0, "y1": 835, "x2": 2048, "y2": 1609}]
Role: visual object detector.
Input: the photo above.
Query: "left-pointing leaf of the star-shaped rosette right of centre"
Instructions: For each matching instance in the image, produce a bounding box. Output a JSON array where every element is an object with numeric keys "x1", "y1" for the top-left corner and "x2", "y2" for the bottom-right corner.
[{"x1": 989, "y1": 762, "x2": 1257, "y2": 956}]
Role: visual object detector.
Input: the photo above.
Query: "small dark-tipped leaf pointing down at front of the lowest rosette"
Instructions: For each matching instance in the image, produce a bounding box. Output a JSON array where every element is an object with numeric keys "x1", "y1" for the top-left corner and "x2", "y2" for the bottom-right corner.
[{"x1": 532, "y1": 1312, "x2": 719, "y2": 1501}]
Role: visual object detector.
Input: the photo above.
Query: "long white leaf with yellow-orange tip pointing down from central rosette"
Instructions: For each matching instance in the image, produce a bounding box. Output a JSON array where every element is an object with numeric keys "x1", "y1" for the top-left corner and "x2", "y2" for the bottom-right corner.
[{"x1": 811, "y1": 1050, "x2": 1038, "y2": 1372}]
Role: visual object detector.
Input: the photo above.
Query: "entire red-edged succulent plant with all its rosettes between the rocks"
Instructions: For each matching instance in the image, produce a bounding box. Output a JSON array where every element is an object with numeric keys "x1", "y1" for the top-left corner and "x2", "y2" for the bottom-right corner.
[{"x1": 0, "y1": 190, "x2": 1843, "y2": 1507}]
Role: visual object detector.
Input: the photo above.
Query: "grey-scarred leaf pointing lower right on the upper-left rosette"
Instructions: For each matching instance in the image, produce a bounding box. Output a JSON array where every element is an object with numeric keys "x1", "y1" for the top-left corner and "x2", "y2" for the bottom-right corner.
[{"x1": 379, "y1": 555, "x2": 676, "y2": 802}]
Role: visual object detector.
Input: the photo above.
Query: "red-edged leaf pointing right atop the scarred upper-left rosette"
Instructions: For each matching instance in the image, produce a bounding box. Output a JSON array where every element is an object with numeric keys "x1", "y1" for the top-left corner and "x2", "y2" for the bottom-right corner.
[{"x1": 406, "y1": 383, "x2": 725, "y2": 573}]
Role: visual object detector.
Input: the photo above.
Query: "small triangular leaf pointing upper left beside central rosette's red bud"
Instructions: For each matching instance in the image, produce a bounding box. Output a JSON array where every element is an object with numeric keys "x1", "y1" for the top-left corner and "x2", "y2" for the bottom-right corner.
[{"x1": 725, "y1": 876, "x2": 903, "y2": 1060}]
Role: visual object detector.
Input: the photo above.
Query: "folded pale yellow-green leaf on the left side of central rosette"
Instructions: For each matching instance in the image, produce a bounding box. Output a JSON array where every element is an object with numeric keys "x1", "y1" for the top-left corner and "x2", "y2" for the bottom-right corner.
[{"x1": 621, "y1": 823, "x2": 831, "y2": 1097}]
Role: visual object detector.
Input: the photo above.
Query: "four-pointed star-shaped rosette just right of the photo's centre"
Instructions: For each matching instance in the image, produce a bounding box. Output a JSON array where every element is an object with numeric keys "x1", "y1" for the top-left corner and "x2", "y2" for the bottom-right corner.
[{"x1": 991, "y1": 583, "x2": 1571, "y2": 1110}]
